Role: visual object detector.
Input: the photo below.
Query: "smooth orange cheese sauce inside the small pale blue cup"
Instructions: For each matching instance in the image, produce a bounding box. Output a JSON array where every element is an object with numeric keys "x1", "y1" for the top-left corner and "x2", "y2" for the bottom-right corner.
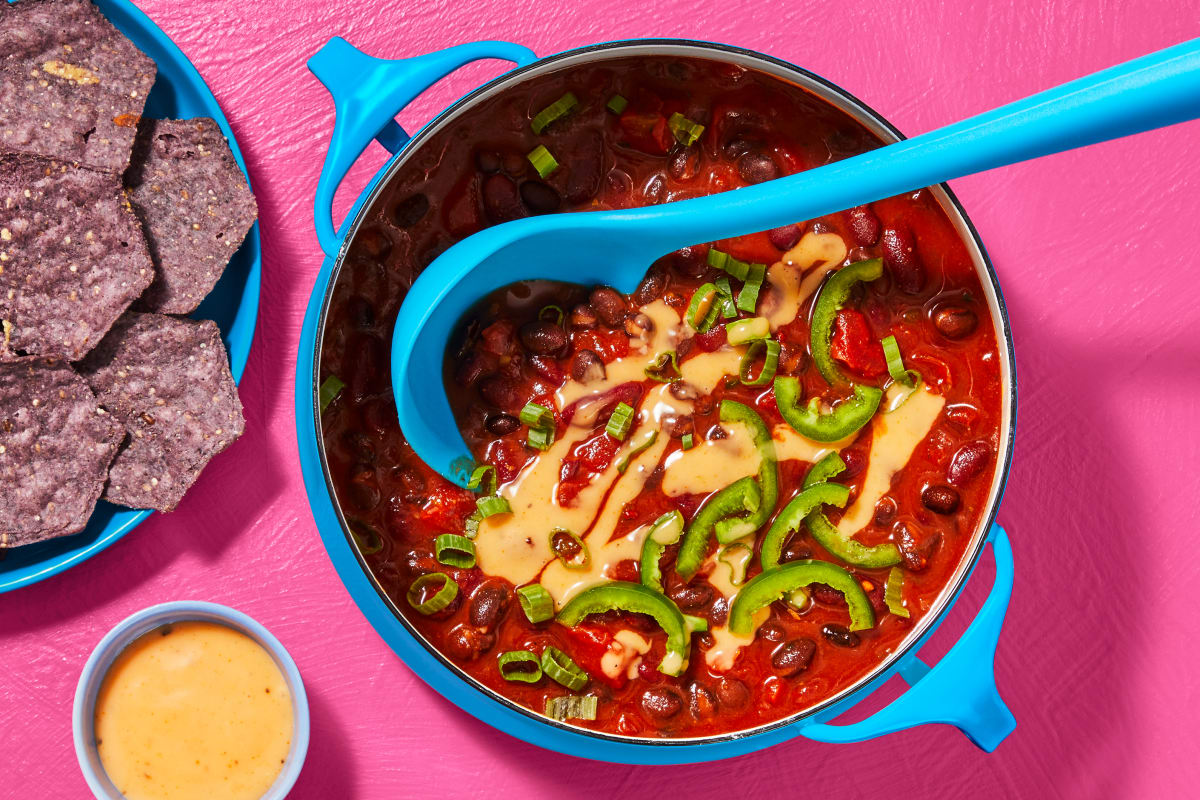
[{"x1": 96, "y1": 622, "x2": 293, "y2": 800}]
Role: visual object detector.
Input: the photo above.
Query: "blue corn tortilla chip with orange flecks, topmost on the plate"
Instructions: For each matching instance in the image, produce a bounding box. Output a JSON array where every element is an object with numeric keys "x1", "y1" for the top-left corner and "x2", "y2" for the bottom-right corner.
[{"x1": 0, "y1": 0, "x2": 156, "y2": 174}]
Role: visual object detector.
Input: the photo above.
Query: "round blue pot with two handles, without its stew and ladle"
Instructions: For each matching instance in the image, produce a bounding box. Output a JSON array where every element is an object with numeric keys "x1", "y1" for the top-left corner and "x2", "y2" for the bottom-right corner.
[{"x1": 295, "y1": 38, "x2": 1016, "y2": 764}]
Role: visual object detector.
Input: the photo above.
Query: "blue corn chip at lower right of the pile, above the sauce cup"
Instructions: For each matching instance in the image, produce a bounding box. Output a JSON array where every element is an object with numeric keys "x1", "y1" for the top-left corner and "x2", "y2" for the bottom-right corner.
[{"x1": 78, "y1": 312, "x2": 245, "y2": 511}]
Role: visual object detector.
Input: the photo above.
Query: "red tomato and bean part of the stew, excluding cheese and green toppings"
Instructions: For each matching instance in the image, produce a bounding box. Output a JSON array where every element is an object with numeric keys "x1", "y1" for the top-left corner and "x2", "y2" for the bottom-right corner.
[{"x1": 320, "y1": 56, "x2": 1002, "y2": 738}]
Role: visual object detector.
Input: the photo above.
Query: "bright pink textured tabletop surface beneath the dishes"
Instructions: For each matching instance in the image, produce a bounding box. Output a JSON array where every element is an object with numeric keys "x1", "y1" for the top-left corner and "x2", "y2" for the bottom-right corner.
[{"x1": 0, "y1": 0, "x2": 1200, "y2": 799}]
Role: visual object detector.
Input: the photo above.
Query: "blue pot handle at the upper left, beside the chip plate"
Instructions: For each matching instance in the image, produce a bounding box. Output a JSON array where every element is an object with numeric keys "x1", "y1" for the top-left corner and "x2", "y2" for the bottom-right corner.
[{"x1": 308, "y1": 36, "x2": 538, "y2": 257}]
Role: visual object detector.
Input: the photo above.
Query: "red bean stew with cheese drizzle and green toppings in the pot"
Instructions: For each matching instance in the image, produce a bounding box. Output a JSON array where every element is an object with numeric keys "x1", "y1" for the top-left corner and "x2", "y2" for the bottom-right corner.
[{"x1": 319, "y1": 56, "x2": 1002, "y2": 738}]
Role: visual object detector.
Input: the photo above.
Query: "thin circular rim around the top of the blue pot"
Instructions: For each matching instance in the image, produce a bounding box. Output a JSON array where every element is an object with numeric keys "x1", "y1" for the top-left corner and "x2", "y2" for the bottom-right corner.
[{"x1": 308, "y1": 37, "x2": 1016, "y2": 748}]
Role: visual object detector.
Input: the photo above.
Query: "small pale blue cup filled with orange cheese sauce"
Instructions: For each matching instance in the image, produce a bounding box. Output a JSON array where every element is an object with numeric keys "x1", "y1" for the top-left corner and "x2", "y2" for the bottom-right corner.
[{"x1": 74, "y1": 602, "x2": 308, "y2": 800}]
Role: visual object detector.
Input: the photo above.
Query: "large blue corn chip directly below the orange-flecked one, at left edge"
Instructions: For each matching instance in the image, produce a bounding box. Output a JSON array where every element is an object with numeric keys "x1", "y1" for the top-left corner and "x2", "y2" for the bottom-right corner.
[{"x1": 0, "y1": 155, "x2": 154, "y2": 361}]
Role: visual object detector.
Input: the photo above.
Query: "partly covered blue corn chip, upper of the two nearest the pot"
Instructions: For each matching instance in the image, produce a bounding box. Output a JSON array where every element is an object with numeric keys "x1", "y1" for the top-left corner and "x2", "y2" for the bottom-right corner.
[{"x1": 125, "y1": 118, "x2": 258, "y2": 314}]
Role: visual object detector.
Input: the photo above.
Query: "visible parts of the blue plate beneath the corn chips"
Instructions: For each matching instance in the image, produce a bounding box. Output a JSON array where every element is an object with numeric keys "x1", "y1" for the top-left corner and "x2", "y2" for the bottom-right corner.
[{"x1": 0, "y1": 0, "x2": 263, "y2": 593}]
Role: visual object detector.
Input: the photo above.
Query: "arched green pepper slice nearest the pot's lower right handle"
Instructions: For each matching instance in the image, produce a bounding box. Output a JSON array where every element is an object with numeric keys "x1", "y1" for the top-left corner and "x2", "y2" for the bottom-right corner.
[{"x1": 730, "y1": 561, "x2": 875, "y2": 636}]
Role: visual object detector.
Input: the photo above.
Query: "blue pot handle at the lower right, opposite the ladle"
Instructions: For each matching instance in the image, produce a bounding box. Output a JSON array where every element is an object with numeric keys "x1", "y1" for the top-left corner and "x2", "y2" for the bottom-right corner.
[{"x1": 800, "y1": 525, "x2": 1016, "y2": 753}]
